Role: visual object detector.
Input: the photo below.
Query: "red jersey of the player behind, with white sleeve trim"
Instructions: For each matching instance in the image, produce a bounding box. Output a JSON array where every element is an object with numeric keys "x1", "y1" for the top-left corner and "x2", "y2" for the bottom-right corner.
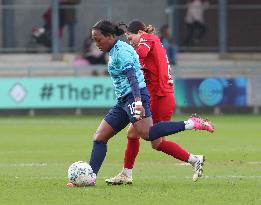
[{"x1": 136, "y1": 34, "x2": 173, "y2": 96}]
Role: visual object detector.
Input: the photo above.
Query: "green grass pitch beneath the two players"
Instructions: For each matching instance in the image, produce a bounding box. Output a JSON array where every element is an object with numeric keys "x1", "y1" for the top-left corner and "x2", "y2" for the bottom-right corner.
[{"x1": 0, "y1": 115, "x2": 261, "y2": 205}]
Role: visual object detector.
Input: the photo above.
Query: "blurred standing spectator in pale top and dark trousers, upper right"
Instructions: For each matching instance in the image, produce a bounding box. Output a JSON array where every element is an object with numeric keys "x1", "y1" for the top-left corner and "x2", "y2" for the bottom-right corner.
[{"x1": 185, "y1": 0, "x2": 209, "y2": 46}]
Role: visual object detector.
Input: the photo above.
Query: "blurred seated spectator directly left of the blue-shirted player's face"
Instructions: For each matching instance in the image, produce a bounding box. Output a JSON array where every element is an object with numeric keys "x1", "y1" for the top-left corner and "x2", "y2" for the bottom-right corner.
[{"x1": 83, "y1": 35, "x2": 107, "y2": 64}]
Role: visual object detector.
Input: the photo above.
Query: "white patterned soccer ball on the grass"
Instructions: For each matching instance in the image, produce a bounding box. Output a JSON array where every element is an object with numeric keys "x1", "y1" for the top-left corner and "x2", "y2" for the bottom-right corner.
[{"x1": 68, "y1": 161, "x2": 96, "y2": 186}]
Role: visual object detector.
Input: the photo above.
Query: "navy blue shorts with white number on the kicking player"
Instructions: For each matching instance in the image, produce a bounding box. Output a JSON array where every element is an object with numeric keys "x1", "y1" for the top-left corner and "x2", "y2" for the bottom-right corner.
[{"x1": 104, "y1": 88, "x2": 151, "y2": 132}]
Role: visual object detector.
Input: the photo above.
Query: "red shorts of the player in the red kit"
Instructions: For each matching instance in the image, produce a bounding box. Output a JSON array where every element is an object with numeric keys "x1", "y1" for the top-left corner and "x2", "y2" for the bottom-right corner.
[{"x1": 150, "y1": 93, "x2": 176, "y2": 123}]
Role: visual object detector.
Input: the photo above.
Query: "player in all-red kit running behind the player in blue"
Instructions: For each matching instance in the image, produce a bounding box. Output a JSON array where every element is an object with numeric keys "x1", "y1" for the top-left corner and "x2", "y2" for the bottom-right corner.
[{"x1": 105, "y1": 21, "x2": 212, "y2": 184}]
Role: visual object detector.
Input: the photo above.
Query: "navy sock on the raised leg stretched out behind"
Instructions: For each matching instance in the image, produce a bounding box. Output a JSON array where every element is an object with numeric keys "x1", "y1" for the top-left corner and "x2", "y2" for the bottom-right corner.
[{"x1": 149, "y1": 121, "x2": 185, "y2": 141}]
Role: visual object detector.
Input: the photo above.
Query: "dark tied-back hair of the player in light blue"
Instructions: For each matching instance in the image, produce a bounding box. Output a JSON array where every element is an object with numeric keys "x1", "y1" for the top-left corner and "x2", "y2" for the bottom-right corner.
[{"x1": 92, "y1": 20, "x2": 126, "y2": 36}]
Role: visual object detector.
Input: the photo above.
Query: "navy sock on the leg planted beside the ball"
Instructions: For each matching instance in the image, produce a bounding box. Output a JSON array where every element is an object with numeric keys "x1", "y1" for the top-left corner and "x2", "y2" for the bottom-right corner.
[{"x1": 89, "y1": 141, "x2": 107, "y2": 175}]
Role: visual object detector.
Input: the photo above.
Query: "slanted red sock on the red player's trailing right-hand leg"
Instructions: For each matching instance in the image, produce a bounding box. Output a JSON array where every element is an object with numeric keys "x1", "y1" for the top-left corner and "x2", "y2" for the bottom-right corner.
[{"x1": 157, "y1": 140, "x2": 189, "y2": 162}]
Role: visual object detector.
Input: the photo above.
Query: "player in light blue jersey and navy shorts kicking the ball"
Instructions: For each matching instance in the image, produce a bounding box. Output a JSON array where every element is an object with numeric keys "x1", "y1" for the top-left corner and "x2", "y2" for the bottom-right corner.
[{"x1": 68, "y1": 20, "x2": 214, "y2": 187}]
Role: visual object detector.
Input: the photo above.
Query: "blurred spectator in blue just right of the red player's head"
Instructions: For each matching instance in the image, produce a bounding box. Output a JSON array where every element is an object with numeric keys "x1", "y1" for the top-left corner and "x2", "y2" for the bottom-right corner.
[{"x1": 160, "y1": 24, "x2": 177, "y2": 64}]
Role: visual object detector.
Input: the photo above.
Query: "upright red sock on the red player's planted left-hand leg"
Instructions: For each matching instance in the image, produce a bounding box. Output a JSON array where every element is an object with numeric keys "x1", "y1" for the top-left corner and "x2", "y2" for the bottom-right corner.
[{"x1": 124, "y1": 138, "x2": 140, "y2": 169}]
